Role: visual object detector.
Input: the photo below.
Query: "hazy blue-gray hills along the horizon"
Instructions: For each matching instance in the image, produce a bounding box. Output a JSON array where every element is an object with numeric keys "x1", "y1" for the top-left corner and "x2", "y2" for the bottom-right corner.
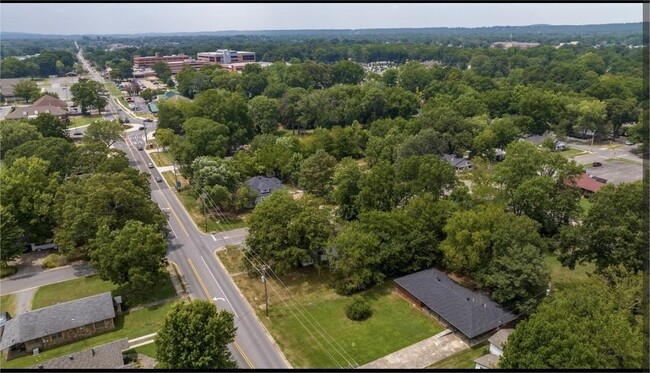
[{"x1": 0, "y1": 22, "x2": 643, "y2": 40}]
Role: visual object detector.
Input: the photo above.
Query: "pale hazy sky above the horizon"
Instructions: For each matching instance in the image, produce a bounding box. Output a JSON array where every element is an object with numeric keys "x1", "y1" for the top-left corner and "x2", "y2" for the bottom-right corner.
[{"x1": 0, "y1": 3, "x2": 643, "y2": 34}]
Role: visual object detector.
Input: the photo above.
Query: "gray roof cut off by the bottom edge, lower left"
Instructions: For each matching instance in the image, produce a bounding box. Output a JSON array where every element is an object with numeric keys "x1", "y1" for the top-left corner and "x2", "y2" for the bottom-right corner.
[{"x1": 32, "y1": 338, "x2": 129, "y2": 369}]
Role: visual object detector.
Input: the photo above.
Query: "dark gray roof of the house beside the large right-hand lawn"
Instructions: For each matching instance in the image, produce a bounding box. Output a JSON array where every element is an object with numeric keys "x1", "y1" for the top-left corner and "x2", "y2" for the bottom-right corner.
[{"x1": 395, "y1": 268, "x2": 518, "y2": 338}]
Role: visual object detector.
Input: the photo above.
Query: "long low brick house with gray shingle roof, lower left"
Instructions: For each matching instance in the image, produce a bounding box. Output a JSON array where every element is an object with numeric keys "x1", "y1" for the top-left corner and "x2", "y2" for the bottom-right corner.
[{"x1": 0, "y1": 292, "x2": 122, "y2": 360}]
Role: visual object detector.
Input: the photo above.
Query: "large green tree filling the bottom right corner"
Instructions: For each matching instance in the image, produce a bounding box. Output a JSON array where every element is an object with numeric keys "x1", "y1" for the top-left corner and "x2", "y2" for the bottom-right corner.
[{"x1": 500, "y1": 276, "x2": 644, "y2": 370}]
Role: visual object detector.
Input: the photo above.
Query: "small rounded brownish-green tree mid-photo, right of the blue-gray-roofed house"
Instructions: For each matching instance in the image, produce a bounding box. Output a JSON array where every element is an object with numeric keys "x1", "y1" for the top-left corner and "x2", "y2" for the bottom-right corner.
[{"x1": 299, "y1": 150, "x2": 337, "y2": 197}]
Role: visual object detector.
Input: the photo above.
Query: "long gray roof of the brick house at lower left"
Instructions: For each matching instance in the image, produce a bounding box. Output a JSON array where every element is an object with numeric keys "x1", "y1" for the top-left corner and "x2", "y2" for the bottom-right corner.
[{"x1": 0, "y1": 292, "x2": 115, "y2": 350}]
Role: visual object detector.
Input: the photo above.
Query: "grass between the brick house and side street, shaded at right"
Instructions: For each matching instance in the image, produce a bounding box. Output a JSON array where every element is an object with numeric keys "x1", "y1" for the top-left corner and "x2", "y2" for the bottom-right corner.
[{"x1": 32, "y1": 275, "x2": 176, "y2": 309}]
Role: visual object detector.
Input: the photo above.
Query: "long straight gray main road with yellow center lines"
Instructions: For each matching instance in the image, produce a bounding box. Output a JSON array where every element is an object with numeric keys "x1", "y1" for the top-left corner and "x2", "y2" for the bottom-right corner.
[{"x1": 80, "y1": 52, "x2": 288, "y2": 369}]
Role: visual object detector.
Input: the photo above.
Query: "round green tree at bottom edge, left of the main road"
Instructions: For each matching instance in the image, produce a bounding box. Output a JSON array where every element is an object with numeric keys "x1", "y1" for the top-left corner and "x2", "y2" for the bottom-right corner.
[{"x1": 155, "y1": 299, "x2": 237, "y2": 369}]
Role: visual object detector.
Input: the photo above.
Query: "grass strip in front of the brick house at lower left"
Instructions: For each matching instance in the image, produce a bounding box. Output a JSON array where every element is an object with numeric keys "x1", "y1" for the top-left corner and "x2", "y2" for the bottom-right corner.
[{"x1": 2, "y1": 302, "x2": 173, "y2": 369}]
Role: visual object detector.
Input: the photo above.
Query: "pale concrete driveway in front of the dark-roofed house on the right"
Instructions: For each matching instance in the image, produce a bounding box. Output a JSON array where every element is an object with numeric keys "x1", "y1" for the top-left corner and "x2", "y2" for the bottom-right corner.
[{"x1": 360, "y1": 329, "x2": 469, "y2": 369}]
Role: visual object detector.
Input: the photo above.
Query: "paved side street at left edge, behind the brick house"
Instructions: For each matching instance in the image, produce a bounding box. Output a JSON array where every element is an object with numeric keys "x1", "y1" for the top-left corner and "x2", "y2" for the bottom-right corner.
[{"x1": 0, "y1": 264, "x2": 95, "y2": 295}]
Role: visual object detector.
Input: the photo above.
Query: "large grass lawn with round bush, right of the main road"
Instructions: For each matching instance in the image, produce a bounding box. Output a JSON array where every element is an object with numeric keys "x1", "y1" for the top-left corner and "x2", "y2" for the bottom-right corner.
[{"x1": 219, "y1": 247, "x2": 444, "y2": 368}]
